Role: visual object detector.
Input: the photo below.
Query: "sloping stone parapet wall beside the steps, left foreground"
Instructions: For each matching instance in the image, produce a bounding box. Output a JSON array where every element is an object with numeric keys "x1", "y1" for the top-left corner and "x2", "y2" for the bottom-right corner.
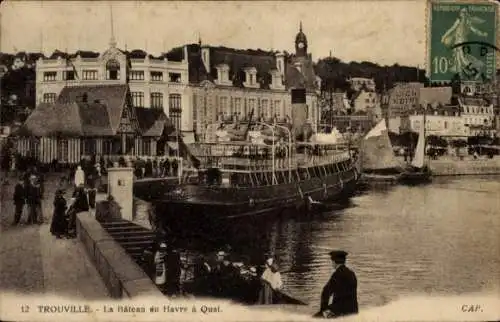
[{"x1": 76, "y1": 212, "x2": 163, "y2": 299}]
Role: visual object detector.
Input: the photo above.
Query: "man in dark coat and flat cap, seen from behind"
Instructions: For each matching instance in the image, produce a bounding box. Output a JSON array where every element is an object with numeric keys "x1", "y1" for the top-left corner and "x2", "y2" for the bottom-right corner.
[{"x1": 316, "y1": 250, "x2": 358, "y2": 317}]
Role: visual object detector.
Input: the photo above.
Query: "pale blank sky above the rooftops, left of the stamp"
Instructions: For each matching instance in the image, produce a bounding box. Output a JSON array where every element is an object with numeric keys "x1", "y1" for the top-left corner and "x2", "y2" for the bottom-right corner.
[{"x1": 0, "y1": 0, "x2": 434, "y2": 68}]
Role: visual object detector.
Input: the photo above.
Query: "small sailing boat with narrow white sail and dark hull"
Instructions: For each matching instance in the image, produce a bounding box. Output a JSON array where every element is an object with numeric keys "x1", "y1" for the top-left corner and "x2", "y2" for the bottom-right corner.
[{"x1": 400, "y1": 115, "x2": 431, "y2": 184}]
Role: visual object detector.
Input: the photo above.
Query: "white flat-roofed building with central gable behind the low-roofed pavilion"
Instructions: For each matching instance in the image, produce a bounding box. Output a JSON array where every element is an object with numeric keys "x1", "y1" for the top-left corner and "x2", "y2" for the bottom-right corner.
[{"x1": 36, "y1": 38, "x2": 192, "y2": 135}]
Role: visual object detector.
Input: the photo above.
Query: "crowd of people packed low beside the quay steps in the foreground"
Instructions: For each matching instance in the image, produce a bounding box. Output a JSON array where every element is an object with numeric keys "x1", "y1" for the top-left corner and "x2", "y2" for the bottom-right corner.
[{"x1": 141, "y1": 239, "x2": 283, "y2": 304}]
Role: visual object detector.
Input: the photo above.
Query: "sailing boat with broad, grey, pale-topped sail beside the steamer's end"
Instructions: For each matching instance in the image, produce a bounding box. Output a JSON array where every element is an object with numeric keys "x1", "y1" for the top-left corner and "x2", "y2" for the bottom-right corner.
[{"x1": 360, "y1": 119, "x2": 405, "y2": 183}]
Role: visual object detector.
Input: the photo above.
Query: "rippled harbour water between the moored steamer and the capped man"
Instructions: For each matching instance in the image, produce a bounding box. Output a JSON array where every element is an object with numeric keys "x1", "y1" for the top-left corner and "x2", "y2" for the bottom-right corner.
[{"x1": 139, "y1": 176, "x2": 500, "y2": 309}]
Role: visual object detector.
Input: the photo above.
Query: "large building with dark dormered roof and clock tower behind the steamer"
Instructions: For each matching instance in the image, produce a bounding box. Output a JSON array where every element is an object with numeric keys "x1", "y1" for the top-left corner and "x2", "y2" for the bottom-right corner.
[{"x1": 178, "y1": 25, "x2": 319, "y2": 136}]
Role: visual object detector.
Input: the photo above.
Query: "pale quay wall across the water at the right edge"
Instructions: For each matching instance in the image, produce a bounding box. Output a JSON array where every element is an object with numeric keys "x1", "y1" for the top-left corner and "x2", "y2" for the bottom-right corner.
[{"x1": 429, "y1": 156, "x2": 500, "y2": 176}]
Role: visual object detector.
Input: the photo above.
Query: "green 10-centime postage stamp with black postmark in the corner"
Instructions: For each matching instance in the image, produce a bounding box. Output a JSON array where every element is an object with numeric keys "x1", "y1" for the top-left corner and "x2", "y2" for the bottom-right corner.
[{"x1": 427, "y1": 1, "x2": 498, "y2": 82}]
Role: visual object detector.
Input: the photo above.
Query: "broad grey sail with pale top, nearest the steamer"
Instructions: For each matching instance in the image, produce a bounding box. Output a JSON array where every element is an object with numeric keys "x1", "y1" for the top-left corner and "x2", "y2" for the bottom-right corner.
[{"x1": 361, "y1": 120, "x2": 400, "y2": 170}]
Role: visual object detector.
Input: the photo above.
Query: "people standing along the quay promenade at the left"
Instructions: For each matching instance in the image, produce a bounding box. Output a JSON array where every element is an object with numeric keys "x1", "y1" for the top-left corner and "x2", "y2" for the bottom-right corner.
[{"x1": 2, "y1": 154, "x2": 179, "y2": 234}]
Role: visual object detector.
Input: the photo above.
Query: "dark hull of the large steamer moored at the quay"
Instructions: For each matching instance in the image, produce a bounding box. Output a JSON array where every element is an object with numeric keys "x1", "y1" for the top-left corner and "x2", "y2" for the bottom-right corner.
[{"x1": 155, "y1": 168, "x2": 359, "y2": 226}]
